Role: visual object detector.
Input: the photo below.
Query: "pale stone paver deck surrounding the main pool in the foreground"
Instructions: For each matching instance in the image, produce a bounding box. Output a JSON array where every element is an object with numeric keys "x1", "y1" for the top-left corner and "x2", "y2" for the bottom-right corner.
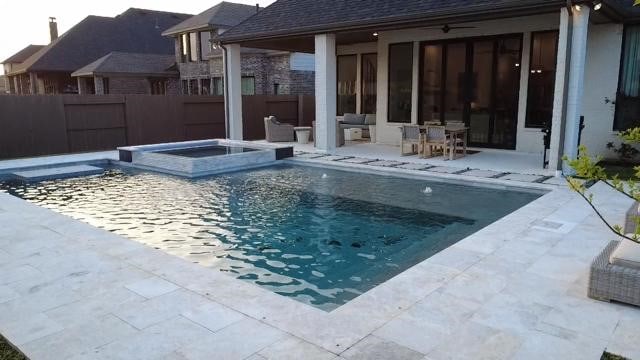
[{"x1": 0, "y1": 154, "x2": 640, "y2": 360}]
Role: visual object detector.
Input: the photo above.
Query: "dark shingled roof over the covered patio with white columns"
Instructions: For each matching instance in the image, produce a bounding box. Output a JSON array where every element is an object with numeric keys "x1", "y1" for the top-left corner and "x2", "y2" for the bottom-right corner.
[{"x1": 220, "y1": 0, "x2": 566, "y2": 43}]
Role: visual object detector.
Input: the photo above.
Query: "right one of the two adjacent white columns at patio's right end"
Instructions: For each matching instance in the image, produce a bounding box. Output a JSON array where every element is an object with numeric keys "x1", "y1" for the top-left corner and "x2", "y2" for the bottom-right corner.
[{"x1": 562, "y1": 5, "x2": 590, "y2": 174}]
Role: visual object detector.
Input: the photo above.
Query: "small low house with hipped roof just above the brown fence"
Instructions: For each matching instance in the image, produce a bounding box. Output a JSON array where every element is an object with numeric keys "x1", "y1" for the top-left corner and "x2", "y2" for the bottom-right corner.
[{"x1": 71, "y1": 52, "x2": 179, "y2": 95}]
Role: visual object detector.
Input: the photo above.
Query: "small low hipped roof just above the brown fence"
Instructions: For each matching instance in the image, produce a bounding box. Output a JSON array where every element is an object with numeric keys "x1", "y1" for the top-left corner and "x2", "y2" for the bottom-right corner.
[{"x1": 71, "y1": 52, "x2": 178, "y2": 77}]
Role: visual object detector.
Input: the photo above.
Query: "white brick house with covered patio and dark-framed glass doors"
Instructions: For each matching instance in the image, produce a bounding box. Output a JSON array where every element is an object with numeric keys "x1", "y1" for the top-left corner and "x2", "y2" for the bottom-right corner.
[{"x1": 219, "y1": 0, "x2": 640, "y2": 171}]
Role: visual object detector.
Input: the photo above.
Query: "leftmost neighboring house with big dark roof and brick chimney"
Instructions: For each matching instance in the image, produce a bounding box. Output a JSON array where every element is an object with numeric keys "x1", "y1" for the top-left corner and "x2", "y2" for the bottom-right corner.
[{"x1": 7, "y1": 8, "x2": 191, "y2": 94}]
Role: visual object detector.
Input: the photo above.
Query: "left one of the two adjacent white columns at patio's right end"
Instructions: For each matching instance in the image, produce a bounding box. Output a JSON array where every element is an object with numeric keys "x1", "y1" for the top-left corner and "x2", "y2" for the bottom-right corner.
[{"x1": 549, "y1": 8, "x2": 569, "y2": 170}]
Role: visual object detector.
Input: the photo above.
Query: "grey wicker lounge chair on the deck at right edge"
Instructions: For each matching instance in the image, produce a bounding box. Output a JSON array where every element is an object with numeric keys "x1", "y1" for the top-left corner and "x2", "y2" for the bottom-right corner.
[{"x1": 588, "y1": 241, "x2": 640, "y2": 306}]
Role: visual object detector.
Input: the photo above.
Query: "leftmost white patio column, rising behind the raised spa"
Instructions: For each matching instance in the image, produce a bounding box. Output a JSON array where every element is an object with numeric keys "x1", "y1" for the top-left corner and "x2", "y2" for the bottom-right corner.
[{"x1": 224, "y1": 44, "x2": 243, "y2": 140}]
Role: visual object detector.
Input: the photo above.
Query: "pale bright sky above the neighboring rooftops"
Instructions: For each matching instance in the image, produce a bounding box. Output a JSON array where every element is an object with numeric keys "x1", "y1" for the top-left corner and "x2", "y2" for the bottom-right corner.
[{"x1": 0, "y1": 0, "x2": 273, "y2": 74}]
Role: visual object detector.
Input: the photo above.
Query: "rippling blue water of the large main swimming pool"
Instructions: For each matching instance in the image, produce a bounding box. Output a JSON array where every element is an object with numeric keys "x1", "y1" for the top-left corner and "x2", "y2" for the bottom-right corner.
[{"x1": 0, "y1": 165, "x2": 540, "y2": 311}]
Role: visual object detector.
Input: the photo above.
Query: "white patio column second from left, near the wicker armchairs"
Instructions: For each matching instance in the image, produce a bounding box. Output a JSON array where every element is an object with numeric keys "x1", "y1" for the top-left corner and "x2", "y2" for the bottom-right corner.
[{"x1": 315, "y1": 34, "x2": 337, "y2": 152}]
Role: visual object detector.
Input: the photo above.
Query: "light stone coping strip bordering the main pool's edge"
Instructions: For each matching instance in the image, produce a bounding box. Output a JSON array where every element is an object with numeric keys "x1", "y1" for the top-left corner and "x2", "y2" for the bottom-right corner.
[{"x1": 0, "y1": 153, "x2": 622, "y2": 355}]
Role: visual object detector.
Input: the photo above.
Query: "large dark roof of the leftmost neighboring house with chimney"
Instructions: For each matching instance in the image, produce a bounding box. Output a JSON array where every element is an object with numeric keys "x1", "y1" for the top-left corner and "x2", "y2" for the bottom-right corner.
[{"x1": 11, "y1": 8, "x2": 191, "y2": 74}]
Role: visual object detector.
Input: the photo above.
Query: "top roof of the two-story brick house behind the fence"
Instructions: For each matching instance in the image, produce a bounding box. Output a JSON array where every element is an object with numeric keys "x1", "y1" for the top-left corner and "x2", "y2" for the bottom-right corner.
[{"x1": 162, "y1": 1, "x2": 258, "y2": 36}]
